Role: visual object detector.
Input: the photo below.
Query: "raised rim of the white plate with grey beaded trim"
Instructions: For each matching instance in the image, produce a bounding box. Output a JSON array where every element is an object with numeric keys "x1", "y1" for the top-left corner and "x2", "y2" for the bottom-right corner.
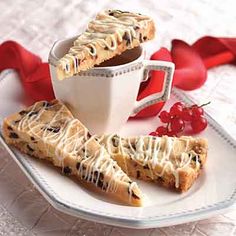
[{"x1": 0, "y1": 72, "x2": 236, "y2": 228}]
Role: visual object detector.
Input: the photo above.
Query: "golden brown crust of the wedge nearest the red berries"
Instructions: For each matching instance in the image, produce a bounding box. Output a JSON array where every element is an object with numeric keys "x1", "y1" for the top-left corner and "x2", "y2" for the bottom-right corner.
[{"x1": 98, "y1": 137, "x2": 208, "y2": 192}]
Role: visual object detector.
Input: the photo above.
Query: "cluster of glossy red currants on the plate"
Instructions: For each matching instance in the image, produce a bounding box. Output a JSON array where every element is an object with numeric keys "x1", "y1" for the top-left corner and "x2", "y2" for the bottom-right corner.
[{"x1": 150, "y1": 102, "x2": 209, "y2": 136}]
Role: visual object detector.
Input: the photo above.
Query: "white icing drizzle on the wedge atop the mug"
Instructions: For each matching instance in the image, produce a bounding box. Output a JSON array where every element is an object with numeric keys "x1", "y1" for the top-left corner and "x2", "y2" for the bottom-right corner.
[{"x1": 59, "y1": 10, "x2": 151, "y2": 74}]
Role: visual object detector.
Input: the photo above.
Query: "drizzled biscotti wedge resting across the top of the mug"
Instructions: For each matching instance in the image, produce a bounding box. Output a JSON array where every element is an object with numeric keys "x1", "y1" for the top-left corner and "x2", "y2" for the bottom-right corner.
[{"x1": 57, "y1": 10, "x2": 155, "y2": 80}]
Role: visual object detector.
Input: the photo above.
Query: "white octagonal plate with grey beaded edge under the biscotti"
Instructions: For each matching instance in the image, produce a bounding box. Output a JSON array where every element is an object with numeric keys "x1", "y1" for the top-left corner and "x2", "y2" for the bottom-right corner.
[{"x1": 0, "y1": 70, "x2": 236, "y2": 228}]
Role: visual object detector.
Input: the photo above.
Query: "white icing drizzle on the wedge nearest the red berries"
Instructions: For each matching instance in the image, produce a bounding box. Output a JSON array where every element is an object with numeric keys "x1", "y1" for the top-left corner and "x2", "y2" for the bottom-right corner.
[{"x1": 99, "y1": 135, "x2": 200, "y2": 188}]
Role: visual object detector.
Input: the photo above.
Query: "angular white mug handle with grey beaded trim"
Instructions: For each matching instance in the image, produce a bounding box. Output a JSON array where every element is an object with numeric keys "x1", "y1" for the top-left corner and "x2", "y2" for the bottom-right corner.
[{"x1": 131, "y1": 60, "x2": 175, "y2": 116}]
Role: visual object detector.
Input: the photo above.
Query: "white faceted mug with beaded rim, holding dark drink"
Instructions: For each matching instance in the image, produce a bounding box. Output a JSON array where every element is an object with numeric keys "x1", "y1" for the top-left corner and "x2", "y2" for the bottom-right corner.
[{"x1": 49, "y1": 38, "x2": 174, "y2": 134}]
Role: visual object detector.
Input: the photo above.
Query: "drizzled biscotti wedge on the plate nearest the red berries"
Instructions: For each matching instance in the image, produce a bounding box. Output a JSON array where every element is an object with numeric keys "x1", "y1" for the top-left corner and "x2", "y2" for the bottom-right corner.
[{"x1": 97, "y1": 135, "x2": 207, "y2": 192}]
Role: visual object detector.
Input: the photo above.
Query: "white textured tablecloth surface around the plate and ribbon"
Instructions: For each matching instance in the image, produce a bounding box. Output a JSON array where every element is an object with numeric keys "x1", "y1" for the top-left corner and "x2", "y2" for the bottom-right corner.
[{"x1": 0, "y1": 0, "x2": 236, "y2": 236}]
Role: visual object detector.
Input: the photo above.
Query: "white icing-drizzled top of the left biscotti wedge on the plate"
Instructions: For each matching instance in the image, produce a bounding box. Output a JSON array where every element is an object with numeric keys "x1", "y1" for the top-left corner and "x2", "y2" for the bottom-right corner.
[{"x1": 18, "y1": 102, "x2": 137, "y2": 197}]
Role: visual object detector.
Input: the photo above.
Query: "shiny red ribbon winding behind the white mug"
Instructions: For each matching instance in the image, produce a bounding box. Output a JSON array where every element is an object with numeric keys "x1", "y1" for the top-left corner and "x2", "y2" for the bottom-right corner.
[{"x1": 0, "y1": 36, "x2": 236, "y2": 118}]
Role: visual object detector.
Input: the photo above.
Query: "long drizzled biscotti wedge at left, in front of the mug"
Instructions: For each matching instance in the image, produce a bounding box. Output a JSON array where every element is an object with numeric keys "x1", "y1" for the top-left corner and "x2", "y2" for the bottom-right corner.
[{"x1": 3, "y1": 100, "x2": 142, "y2": 206}]
